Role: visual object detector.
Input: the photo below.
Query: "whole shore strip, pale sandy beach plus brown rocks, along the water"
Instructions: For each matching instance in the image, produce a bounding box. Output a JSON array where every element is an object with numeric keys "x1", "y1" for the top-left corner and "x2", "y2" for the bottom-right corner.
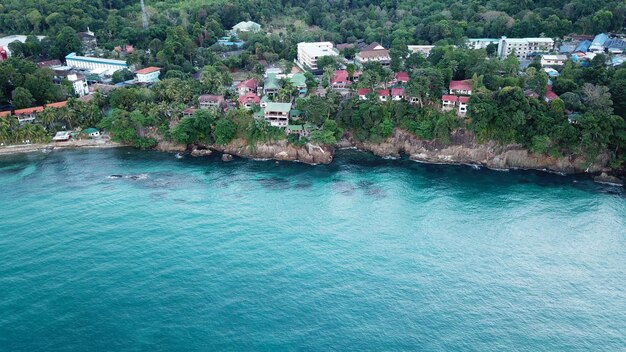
[{"x1": 0, "y1": 129, "x2": 625, "y2": 186}]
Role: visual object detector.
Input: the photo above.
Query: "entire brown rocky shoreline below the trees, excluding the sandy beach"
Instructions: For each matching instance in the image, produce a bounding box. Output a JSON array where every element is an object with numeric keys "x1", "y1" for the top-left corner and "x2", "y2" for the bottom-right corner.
[{"x1": 177, "y1": 129, "x2": 624, "y2": 185}]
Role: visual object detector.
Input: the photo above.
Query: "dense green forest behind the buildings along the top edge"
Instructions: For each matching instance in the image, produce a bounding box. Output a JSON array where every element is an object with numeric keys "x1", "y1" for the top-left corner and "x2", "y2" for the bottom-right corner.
[{"x1": 0, "y1": 0, "x2": 626, "y2": 47}]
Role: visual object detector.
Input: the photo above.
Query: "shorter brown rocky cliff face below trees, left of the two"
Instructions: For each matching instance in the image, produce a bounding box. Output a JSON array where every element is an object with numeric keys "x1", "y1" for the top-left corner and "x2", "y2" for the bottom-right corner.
[{"x1": 211, "y1": 139, "x2": 334, "y2": 164}]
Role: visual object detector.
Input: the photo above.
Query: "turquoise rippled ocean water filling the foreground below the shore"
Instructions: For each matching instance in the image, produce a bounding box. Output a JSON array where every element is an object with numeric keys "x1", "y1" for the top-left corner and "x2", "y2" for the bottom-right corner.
[{"x1": 0, "y1": 149, "x2": 626, "y2": 351}]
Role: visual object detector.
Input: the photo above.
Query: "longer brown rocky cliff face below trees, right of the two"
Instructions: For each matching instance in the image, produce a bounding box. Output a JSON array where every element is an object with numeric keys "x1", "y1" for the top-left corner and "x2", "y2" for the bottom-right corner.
[{"x1": 344, "y1": 129, "x2": 608, "y2": 173}]
